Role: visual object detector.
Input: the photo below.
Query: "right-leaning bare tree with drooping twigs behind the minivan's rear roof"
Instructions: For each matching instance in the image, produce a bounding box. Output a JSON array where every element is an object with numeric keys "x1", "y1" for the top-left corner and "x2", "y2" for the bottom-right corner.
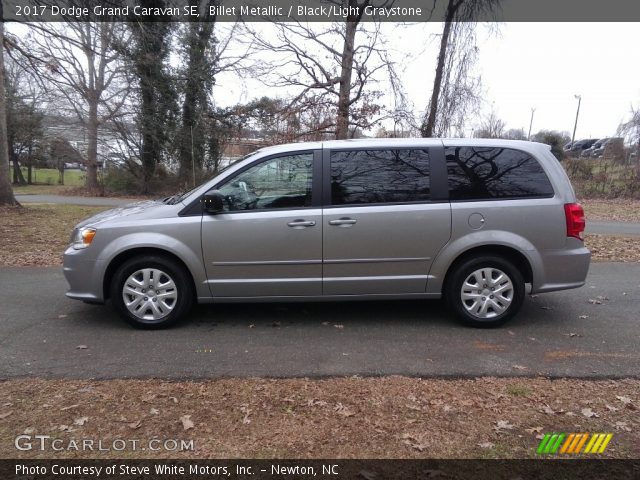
[{"x1": 420, "y1": 0, "x2": 500, "y2": 137}]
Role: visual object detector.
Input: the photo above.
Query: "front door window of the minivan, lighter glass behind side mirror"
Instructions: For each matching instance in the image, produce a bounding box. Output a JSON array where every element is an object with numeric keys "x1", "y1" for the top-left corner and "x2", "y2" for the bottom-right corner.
[{"x1": 218, "y1": 153, "x2": 313, "y2": 212}]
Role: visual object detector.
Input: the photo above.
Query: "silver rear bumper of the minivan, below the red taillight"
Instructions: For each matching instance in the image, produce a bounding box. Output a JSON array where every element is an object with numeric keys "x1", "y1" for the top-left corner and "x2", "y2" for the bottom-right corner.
[{"x1": 531, "y1": 244, "x2": 591, "y2": 293}]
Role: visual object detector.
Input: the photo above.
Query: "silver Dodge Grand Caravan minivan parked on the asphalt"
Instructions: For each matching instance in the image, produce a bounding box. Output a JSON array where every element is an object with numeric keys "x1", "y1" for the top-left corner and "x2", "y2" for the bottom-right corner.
[{"x1": 64, "y1": 139, "x2": 590, "y2": 328}]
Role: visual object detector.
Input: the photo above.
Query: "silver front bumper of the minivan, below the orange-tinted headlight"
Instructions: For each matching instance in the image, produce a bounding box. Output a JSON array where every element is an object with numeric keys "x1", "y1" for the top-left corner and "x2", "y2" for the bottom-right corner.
[{"x1": 62, "y1": 247, "x2": 104, "y2": 303}]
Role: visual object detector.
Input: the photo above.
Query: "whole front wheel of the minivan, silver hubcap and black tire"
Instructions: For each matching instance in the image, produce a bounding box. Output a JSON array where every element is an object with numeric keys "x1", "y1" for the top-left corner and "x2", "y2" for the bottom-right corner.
[{"x1": 111, "y1": 255, "x2": 193, "y2": 329}]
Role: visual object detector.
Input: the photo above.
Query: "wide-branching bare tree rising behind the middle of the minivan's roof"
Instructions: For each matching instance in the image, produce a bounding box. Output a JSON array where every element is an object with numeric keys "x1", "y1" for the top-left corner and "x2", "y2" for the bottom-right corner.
[{"x1": 252, "y1": 0, "x2": 400, "y2": 139}]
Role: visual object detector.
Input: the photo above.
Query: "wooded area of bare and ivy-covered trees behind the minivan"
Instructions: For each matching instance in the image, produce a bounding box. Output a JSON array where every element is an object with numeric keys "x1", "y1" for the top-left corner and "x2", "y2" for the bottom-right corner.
[{"x1": 0, "y1": 0, "x2": 640, "y2": 205}]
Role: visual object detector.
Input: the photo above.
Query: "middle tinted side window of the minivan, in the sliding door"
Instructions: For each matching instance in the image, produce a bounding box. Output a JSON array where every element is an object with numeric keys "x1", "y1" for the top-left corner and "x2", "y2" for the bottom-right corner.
[{"x1": 331, "y1": 150, "x2": 430, "y2": 205}]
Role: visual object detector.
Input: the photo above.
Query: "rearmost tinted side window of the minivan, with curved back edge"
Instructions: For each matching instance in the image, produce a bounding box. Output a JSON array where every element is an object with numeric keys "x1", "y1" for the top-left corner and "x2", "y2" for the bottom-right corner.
[{"x1": 445, "y1": 147, "x2": 553, "y2": 200}]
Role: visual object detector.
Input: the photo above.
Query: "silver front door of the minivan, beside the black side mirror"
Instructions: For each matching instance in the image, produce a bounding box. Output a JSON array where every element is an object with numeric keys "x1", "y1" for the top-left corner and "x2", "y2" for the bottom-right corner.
[{"x1": 202, "y1": 152, "x2": 322, "y2": 297}]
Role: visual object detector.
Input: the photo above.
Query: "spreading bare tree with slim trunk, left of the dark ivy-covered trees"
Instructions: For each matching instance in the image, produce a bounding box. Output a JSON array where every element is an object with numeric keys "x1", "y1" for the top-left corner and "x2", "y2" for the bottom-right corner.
[{"x1": 22, "y1": 22, "x2": 128, "y2": 189}]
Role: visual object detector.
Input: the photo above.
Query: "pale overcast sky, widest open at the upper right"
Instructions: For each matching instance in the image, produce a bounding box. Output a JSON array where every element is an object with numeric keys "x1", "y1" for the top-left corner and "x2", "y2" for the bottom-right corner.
[{"x1": 217, "y1": 23, "x2": 640, "y2": 139}]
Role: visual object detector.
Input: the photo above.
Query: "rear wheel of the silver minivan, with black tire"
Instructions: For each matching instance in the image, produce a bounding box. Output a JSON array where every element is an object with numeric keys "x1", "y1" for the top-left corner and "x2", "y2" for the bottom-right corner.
[{"x1": 444, "y1": 256, "x2": 524, "y2": 328}]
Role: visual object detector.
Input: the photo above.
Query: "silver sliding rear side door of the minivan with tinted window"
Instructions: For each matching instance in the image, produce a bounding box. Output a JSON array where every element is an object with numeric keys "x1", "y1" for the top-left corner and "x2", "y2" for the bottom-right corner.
[{"x1": 323, "y1": 148, "x2": 451, "y2": 295}]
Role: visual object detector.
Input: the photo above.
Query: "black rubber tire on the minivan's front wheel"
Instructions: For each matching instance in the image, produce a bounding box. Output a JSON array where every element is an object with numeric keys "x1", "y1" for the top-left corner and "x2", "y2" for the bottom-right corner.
[{"x1": 110, "y1": 255, "x2": 194, "y2": 330}]
